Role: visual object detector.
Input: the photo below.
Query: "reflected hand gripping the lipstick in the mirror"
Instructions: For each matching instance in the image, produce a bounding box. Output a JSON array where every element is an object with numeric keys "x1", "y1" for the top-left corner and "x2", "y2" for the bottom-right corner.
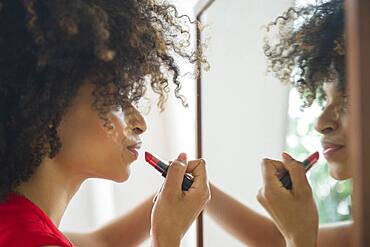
[{"x1": 257, "y1": 153, "x2": 319, "y2": 247}]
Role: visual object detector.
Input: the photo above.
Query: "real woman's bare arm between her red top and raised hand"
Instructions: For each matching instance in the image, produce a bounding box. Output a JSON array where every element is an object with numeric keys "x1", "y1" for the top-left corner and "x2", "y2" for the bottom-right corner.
[{"x1": 65, "y1": 196, "x2": 153, "y2": 247}]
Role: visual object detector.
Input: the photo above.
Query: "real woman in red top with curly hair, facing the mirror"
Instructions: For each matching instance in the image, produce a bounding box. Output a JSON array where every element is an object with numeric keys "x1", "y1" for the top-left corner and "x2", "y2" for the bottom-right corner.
[{"x1": 0, "y1": 0, "x2": 210, "y2": 247}]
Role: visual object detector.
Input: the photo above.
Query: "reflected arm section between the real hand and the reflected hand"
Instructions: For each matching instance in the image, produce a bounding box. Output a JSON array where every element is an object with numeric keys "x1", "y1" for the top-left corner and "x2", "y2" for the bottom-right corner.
[{"x1": 206, "y1": 184, "x2": 285, "y2": 247}]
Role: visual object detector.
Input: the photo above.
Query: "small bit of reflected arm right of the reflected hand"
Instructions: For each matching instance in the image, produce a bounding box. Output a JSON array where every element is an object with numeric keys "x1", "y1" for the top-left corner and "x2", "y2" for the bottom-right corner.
[{"x1": 318, "y1": 221, "x2": 353, "y2": 247}]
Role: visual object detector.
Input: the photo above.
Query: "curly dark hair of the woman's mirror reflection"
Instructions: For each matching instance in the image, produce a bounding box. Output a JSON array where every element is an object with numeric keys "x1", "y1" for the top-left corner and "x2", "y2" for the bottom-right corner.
[{"x1": 264, "y1": 0, "x2": 346, "y2": 107}]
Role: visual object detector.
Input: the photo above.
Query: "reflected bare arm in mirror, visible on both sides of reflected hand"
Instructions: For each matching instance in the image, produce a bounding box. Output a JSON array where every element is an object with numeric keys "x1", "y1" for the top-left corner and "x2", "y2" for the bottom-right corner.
[{"x1": 206, "y1": 184, "x2": 353, "y2": 247}]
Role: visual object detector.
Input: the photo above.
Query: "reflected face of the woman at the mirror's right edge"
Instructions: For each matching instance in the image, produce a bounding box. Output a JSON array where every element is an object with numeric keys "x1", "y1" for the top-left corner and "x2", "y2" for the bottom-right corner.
[{"x1": 315, "y1": 83, "x2": 351, "y2": 180}]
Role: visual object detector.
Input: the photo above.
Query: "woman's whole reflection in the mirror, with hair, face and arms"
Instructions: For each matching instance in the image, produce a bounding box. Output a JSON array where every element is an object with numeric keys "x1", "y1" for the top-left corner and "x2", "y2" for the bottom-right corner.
[{"x1": 207, "y1": 0, "x2": 352, "y2": 247}]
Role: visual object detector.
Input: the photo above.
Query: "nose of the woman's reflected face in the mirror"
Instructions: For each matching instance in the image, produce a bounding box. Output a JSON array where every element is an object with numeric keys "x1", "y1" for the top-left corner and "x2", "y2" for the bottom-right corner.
[{"x1": 315, "y1": 106, "x2": 339, "y2": 135}]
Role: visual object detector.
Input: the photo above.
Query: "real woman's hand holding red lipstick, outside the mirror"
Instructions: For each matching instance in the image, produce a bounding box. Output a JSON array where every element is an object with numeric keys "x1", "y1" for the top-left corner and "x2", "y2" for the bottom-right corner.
[{"x1": 151, "y1": 154, "x2": 210, "y2": 247}]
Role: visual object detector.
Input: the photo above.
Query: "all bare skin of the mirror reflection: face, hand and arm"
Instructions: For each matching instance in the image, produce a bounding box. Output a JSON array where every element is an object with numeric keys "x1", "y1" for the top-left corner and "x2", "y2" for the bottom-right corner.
[{"x1": 206, "y1": 83, "x2": 352, "y2": 247}]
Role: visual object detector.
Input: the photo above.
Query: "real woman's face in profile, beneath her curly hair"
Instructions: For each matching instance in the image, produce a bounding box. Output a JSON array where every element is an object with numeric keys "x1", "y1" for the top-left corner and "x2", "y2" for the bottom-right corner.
[{"x1": 53, "y1": 83, "x2": 146, "y2": 182}]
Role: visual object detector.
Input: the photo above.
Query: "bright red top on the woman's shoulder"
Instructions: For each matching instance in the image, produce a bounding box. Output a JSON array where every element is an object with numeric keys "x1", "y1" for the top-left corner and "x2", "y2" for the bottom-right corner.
[{"x1": 0, "y1": 193, "x2": 73, "y2": 247}]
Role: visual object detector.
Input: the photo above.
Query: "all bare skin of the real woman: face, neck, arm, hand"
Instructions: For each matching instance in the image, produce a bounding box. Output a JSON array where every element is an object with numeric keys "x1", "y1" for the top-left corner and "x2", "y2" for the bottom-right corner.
[{"x1": 15, "y1": 83, "x2": 210, "y2": 247}]
